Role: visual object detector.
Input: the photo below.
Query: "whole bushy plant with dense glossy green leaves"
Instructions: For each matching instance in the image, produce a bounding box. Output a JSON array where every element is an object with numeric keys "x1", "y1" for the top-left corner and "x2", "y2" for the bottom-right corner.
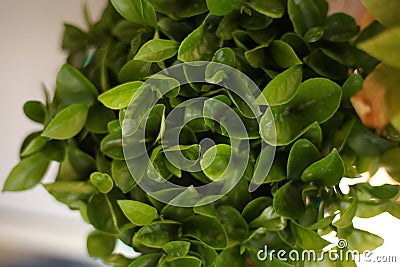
[{"x1": 3, "y1": 0, "x2": 400, "y2": 267}]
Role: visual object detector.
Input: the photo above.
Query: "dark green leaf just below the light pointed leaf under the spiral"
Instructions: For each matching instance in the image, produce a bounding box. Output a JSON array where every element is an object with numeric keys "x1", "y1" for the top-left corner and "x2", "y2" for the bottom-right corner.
[{"x1": 132, "y1": 220, "x2": 181, "y2": 249}]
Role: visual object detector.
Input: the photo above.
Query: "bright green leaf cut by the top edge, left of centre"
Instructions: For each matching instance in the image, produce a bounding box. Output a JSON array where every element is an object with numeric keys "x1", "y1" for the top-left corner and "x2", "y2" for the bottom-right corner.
[{"x1": 111, "y1": 0, "x2": 157, "y2": 28}]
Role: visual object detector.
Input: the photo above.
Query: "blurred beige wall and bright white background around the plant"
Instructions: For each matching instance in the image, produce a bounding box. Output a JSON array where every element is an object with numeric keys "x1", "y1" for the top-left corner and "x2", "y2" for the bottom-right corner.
[{"x1": 0, "y1": 0, "x2": 400, "y2": 267}]
